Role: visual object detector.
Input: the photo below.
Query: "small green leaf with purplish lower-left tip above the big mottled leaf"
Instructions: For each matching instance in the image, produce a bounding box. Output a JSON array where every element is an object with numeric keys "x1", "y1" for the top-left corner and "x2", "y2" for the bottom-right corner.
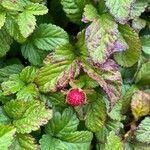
[{"x1": 82, "y1": 4, "x2": 98, "y2": 23}]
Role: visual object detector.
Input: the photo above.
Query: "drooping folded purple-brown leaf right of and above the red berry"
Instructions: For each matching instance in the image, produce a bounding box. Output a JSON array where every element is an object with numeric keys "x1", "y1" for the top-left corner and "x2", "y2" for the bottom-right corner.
[{"x1": 80, "y1": 60, "x2": 122, "y2": 109}]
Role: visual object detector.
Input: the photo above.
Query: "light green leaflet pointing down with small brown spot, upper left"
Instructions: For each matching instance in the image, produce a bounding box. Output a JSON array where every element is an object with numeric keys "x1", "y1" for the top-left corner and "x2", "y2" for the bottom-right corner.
[{"x1": 18, "y1": 11, "x2": 36, "y2": 38}]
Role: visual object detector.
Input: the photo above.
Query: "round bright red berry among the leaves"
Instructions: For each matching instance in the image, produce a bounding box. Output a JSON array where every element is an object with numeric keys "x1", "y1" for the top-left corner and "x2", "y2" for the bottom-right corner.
[{"x1": 66, "y1": 89, "x2": 86, "y2": 106}]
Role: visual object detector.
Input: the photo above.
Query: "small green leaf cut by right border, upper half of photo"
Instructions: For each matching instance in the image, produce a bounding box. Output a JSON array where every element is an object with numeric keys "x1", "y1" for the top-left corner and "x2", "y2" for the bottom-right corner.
[{"x1": 141, "y1": 35, "x2": 150, "y2": 56}]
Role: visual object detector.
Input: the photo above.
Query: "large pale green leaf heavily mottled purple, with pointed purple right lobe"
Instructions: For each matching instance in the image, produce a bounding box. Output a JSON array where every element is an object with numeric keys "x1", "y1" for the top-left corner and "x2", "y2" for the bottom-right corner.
[{"x1": 85, "y1": 14, "x2": 127, "y2": 64}]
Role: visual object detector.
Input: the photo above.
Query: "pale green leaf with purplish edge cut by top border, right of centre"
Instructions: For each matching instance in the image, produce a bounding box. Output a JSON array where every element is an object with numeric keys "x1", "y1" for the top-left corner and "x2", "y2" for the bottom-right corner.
[{"x1": 105, "y1": 0, "x2": 134, "y2": 24}]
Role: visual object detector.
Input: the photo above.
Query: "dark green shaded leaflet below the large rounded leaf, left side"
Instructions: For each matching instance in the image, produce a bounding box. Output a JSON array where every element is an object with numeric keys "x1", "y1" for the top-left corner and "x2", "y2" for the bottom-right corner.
[{"x1": 21, "y1": 41, "x2": 47, "y2": 66}]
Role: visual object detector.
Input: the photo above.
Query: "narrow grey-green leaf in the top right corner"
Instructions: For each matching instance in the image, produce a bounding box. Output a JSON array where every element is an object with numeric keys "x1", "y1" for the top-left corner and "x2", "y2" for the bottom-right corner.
[{"x1": 130, "y1": 0, "x2": 148, "y2": 19}]
